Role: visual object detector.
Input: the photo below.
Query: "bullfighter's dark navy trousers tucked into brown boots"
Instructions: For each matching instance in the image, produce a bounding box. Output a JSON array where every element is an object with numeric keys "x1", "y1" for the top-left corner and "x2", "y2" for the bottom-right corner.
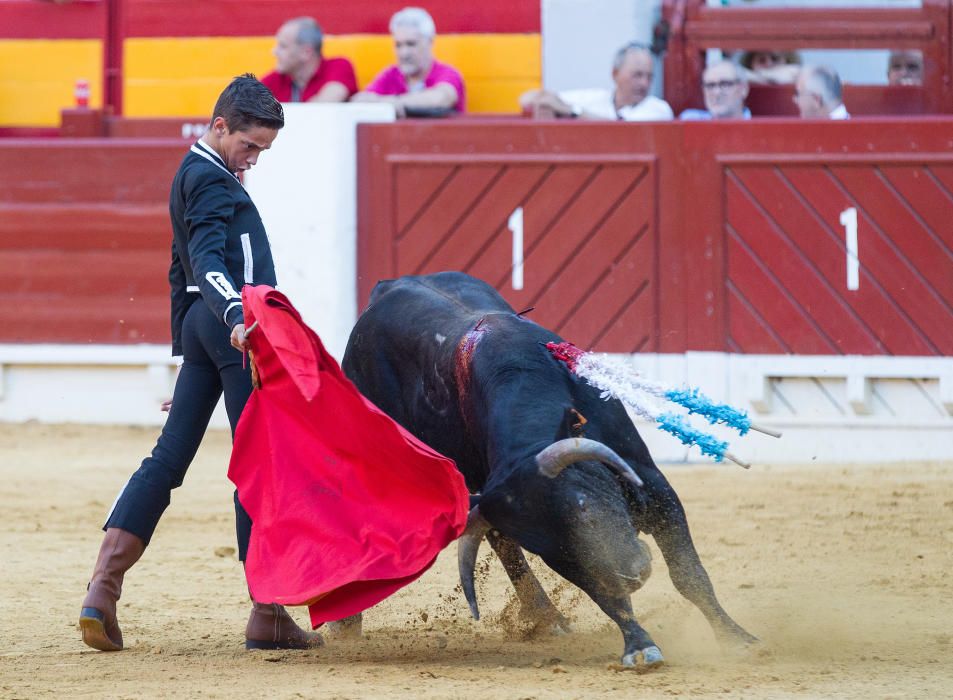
[{"x1": 103, "y1": 295, "x2": 251, "y2": 561}]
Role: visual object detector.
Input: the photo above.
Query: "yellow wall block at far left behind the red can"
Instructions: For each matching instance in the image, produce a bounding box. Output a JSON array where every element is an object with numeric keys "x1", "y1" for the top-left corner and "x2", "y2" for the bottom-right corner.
[{"x1": 0, "y1": 39, "x2": 103, "y2": 127}]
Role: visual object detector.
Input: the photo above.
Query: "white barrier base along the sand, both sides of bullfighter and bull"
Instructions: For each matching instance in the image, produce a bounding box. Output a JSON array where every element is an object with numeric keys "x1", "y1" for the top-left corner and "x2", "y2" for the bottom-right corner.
[{"x1": 0, "y1": 345, "x2": 953, "y2": 464}]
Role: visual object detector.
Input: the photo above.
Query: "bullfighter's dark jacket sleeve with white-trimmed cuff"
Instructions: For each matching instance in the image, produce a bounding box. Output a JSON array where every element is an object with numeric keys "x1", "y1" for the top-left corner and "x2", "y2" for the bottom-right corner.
[{"x1": 185, "y1": 170, "x2": 244, "y2": 328}]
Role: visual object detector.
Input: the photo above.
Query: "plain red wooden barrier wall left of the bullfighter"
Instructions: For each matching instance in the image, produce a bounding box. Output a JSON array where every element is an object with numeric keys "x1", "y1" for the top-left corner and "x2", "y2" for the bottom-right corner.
[{"x1": 0, "y1": 139, "x2": 185, "y2": 344}]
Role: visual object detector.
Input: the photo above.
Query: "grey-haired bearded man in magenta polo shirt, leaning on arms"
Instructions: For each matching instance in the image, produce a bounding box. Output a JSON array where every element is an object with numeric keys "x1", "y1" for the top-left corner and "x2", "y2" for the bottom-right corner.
[{"x1": 352, "y1": 7, "x2": 466, "y2": 117}]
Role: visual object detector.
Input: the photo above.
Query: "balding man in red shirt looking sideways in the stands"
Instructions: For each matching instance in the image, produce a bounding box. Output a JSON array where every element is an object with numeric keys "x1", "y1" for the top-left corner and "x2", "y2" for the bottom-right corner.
[{"x1": 261, "y1": 17, "x2": 357, "y2": 102}]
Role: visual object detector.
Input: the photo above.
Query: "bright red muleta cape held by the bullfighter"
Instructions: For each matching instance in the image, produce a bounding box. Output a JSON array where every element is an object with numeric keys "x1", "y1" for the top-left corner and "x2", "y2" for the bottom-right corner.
[{"x1": 228, "y1": 286, "x2": 469, "y2": 627}]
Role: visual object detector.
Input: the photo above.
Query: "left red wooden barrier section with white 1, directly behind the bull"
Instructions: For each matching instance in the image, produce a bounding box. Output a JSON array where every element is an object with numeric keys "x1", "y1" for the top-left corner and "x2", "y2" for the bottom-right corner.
[{"x1": 358, "y1": 121, "x2": 672, "y2": 352}]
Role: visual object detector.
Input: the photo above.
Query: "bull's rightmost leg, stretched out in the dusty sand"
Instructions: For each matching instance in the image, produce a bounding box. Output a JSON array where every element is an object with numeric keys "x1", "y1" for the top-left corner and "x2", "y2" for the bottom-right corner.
[{"x1": 651, "y1": 492, "x2": 758, "y2": 645}]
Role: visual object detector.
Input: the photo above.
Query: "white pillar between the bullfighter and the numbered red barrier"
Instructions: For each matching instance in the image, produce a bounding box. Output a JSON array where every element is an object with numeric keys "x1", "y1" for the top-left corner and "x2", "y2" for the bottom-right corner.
[{"x1": 245, "y1": 104, "x2": 394, "y2": 361}]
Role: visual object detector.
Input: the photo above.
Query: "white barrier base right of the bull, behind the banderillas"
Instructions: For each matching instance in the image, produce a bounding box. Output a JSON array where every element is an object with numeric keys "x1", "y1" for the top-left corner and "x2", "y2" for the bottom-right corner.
[{"x1": 632, "y1": 352, "x2": 953, "y2": 463}]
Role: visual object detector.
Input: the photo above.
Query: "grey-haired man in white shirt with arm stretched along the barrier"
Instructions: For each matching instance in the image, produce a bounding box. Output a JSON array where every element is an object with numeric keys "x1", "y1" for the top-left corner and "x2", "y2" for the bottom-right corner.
[{"x1": 520, "y1": 43, "x2": 675, "y2": 122}]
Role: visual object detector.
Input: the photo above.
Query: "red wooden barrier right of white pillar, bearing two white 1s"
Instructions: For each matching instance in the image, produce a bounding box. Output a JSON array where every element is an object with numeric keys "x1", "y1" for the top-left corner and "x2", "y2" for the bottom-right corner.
[{"x1": 358, "y1": 118, "x2": 953, "y2": 355}]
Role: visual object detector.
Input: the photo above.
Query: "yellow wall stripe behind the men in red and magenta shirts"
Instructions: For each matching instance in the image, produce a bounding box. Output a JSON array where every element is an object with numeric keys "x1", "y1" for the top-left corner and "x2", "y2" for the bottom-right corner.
[{"x1": 123, "y1": 34, "x2": 542, "y2": 117}]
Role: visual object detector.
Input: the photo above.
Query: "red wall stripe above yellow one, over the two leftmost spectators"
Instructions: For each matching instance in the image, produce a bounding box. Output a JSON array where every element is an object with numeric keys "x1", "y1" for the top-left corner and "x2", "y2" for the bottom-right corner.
[{"x1": 123, "y1": 0, "x2": 540, "y2": 37}]
